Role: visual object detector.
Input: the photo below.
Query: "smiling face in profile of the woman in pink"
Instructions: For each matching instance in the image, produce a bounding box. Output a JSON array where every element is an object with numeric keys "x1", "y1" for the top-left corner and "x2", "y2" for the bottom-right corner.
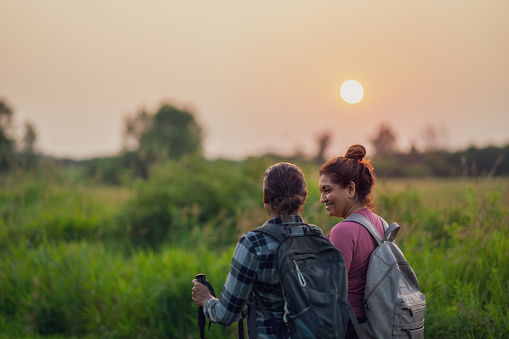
[{"x1": 319, "y1": 174, "x2": 355, "y2": 218}]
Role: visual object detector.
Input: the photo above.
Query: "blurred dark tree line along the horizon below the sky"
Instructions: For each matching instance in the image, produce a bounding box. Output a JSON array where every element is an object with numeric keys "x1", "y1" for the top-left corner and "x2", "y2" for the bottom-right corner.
[{"x1": 0, "y1": 99, "x2": 509, "y2": 184}]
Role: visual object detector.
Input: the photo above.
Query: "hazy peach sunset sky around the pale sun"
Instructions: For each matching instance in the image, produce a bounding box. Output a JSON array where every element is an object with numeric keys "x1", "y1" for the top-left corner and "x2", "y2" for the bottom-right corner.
[{"x1": 0, "y1": 0, "x2": 509, "y2": 158}]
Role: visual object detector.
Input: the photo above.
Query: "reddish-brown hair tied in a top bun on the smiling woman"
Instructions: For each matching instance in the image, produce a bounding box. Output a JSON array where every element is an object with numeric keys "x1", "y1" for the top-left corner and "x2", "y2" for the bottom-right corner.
[{"x1": 319, "y1": 144, "x2": 376, "y2": 208}]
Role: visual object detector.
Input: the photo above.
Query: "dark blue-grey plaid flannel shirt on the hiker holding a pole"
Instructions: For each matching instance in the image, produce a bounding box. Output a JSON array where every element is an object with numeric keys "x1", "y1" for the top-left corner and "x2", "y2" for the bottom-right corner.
[{"x1": 203, "y1": 215, "x2": 314, "y2": 339}]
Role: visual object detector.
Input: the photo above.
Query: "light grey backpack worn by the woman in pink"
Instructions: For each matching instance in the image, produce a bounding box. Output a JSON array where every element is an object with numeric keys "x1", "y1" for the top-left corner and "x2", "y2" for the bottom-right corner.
[{"x1": 344, "y1": 213, "x2": 426, "y2": 339}]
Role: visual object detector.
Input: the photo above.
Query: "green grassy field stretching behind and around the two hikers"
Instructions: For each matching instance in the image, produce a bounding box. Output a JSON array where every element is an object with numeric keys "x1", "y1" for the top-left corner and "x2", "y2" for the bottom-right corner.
[{"x1": 0, "y1": 164, "x2": 509, "y2": 338}]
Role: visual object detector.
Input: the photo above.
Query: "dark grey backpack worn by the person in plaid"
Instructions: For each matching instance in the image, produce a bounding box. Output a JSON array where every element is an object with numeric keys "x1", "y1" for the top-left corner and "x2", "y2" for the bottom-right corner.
[{"x1": 248, "y1": 224, "x2": 349, "y2": 339}]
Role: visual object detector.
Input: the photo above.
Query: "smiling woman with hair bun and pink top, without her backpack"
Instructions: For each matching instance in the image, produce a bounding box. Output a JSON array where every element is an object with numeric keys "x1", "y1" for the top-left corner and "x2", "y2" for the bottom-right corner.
[{"x1": 319, "y1": 145, "x2": 384, "y2": 338}]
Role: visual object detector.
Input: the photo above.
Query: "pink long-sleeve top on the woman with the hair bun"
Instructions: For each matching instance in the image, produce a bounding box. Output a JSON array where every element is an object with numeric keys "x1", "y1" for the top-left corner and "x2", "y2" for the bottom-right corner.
[{"x1": 329, "y1": 208, "x2": 384, "y2": 318}]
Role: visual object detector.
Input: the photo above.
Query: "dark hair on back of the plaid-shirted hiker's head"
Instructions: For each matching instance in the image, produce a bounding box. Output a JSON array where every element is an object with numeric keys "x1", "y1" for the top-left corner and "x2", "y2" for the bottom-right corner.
[{"x1": 263, "y1": 162, "x2": 306, "y2": 215}]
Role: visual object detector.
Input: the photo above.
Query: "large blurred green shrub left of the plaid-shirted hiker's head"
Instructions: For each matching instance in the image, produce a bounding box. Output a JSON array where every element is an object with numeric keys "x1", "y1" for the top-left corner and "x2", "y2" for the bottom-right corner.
[{"x1": 122, "y1": 156, "x2": 267, "y2": 246}]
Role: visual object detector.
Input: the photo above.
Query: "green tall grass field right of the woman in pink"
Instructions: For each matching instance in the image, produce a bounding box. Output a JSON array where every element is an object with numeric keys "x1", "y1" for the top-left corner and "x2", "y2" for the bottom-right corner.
[{"x1": 379, "y1": 179, "x2": 509, "y2": 338}]
